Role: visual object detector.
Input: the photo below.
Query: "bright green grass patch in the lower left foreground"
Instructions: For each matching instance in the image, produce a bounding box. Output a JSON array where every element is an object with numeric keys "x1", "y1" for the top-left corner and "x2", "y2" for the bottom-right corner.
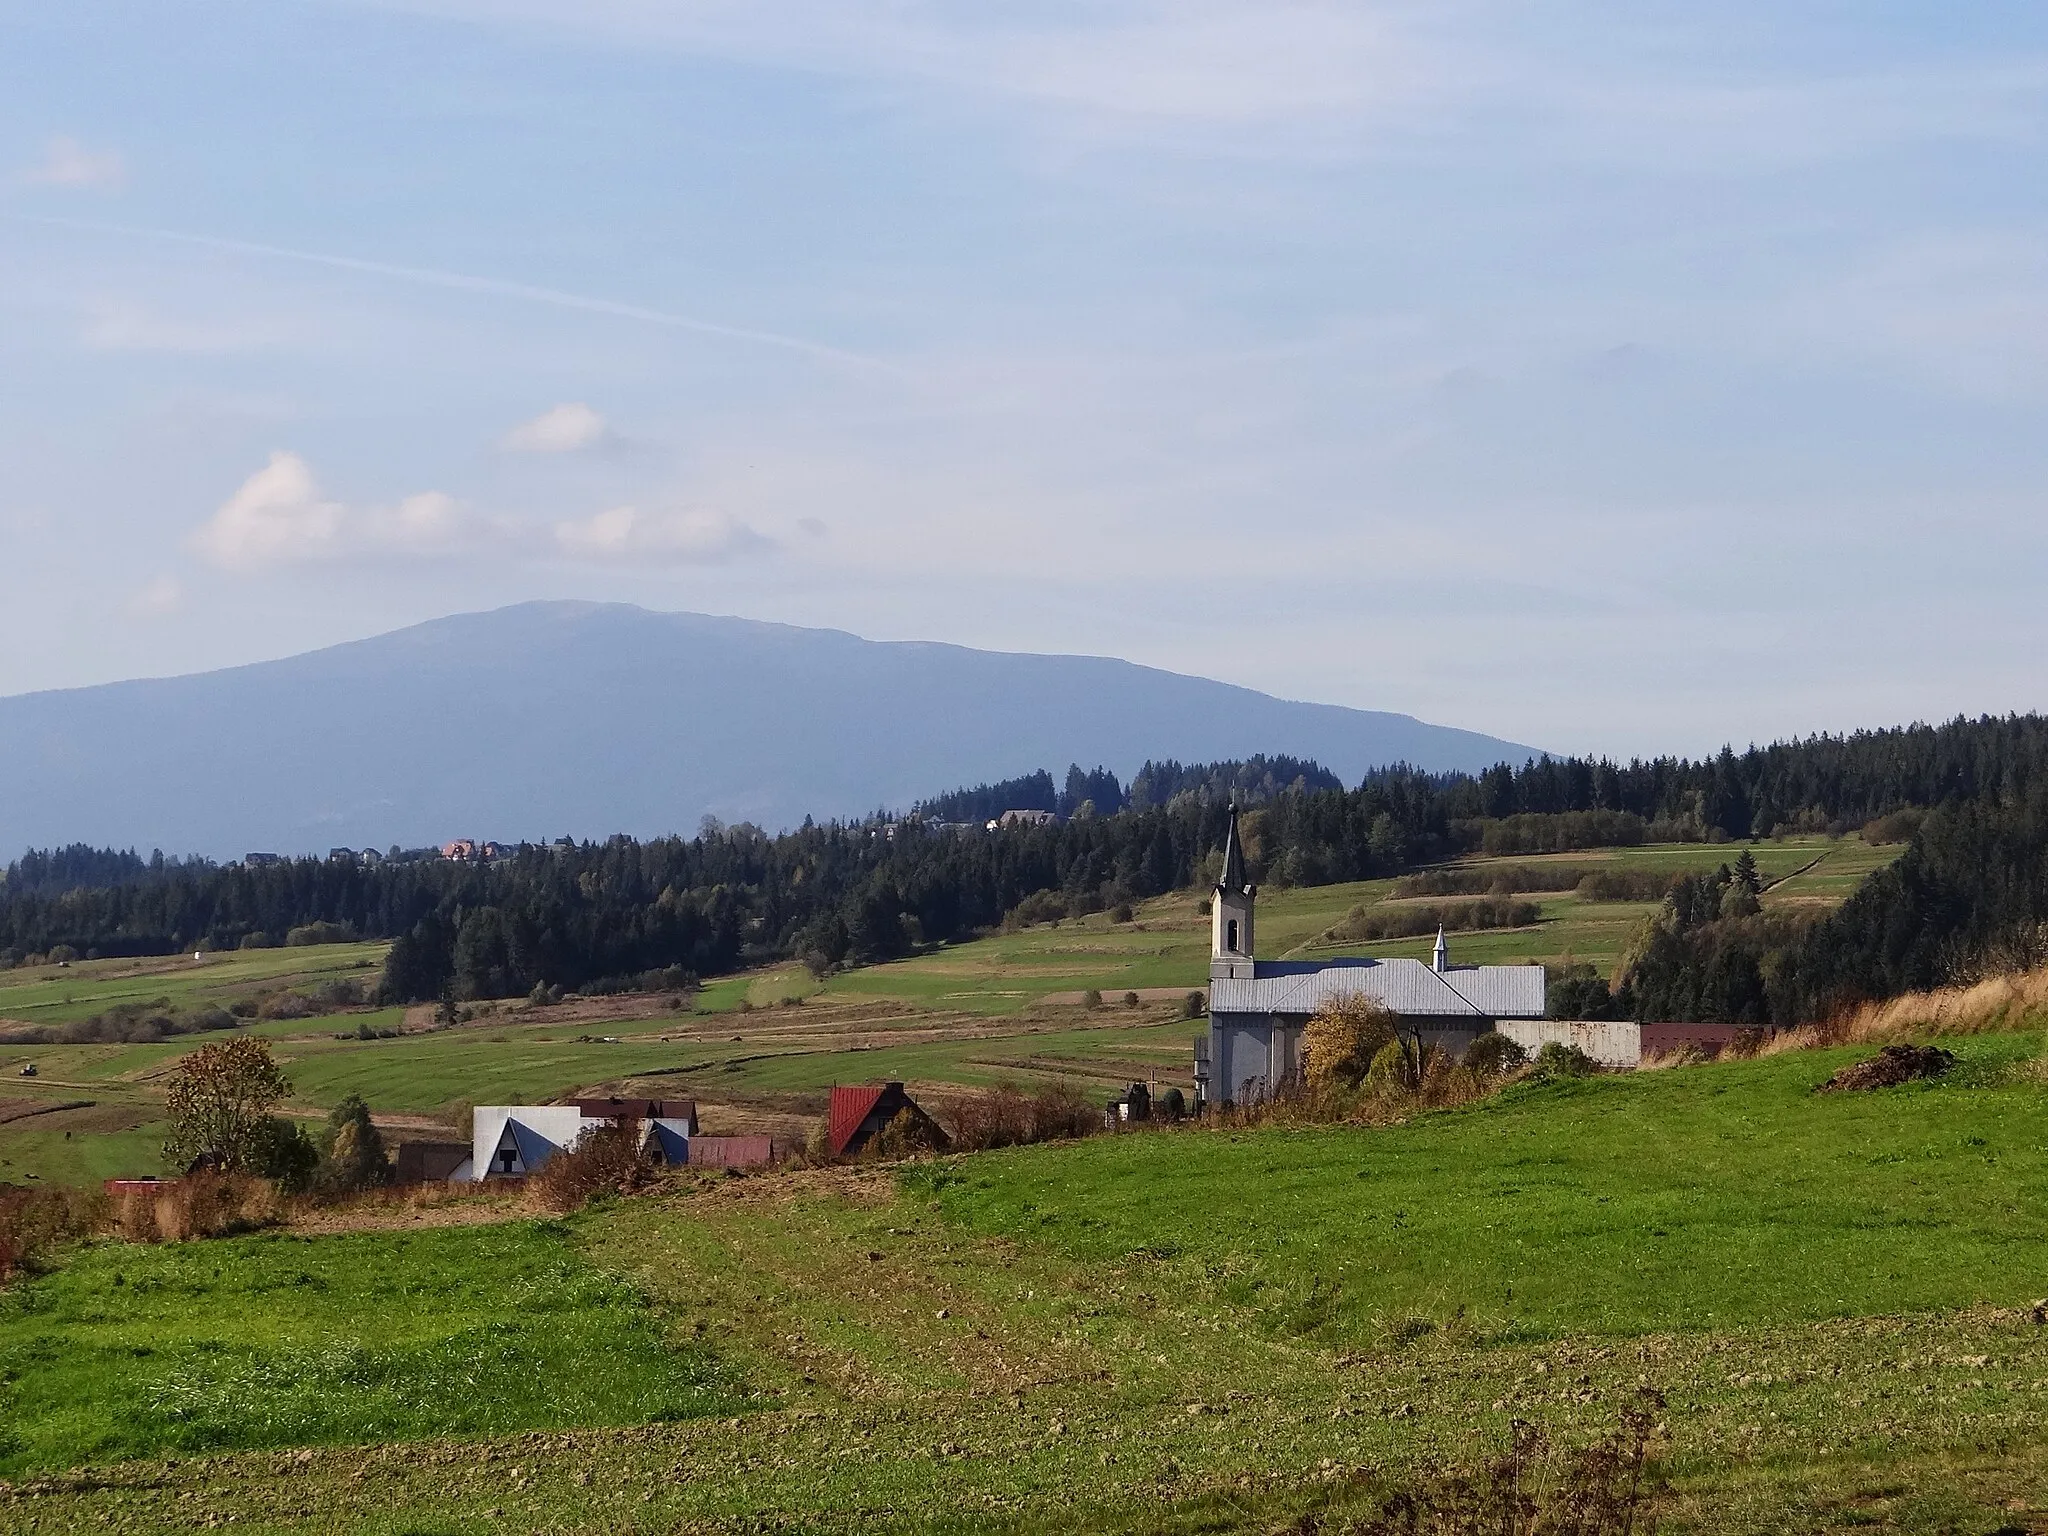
[{"x1": 0, "y1": 1223, "x2": 741, "y2": 1475}]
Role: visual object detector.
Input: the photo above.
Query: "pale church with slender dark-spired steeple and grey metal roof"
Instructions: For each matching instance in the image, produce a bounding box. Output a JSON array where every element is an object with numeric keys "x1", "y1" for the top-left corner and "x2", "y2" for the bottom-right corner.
[{"x1": 1194, "y1": 805, "x2": 1544, "y2": 1106}]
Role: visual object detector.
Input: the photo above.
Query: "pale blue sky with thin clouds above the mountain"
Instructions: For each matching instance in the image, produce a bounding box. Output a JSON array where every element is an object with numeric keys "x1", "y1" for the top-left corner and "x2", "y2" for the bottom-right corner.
[{"x1": 0, "y1": 0, "x2": 2048, "y2": 758}]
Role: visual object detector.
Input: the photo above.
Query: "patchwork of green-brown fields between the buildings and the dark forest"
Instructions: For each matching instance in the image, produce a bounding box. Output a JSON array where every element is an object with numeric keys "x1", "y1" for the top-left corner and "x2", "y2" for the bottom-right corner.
[{"x1": 0, "y1": 838, "x2": 1898, "y2": 1182}]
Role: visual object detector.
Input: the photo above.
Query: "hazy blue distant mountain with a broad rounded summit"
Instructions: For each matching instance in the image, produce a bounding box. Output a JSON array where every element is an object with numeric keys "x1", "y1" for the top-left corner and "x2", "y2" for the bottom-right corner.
[{"x1": 0, "y1": 602, "x2": 1532, "y2": 856}]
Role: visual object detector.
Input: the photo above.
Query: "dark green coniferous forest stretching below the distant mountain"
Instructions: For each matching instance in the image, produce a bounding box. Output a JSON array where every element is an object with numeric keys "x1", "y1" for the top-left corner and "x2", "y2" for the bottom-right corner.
[{"x1": 0, "y1": 715, "x2": 2048, "y2": 1026}]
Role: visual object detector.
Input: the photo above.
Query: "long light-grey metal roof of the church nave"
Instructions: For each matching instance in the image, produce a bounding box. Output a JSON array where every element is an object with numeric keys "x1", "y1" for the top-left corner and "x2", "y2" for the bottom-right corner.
[{"x1": 1208, "y1": 958, "x2": 1544, "y2": 1018}]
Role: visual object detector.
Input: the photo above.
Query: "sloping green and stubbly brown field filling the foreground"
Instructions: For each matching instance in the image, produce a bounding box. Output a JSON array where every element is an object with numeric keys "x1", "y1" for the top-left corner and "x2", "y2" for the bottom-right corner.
[{"x1": 0, "y1": 1034, "x2": 2048, "y2": 1536}]
